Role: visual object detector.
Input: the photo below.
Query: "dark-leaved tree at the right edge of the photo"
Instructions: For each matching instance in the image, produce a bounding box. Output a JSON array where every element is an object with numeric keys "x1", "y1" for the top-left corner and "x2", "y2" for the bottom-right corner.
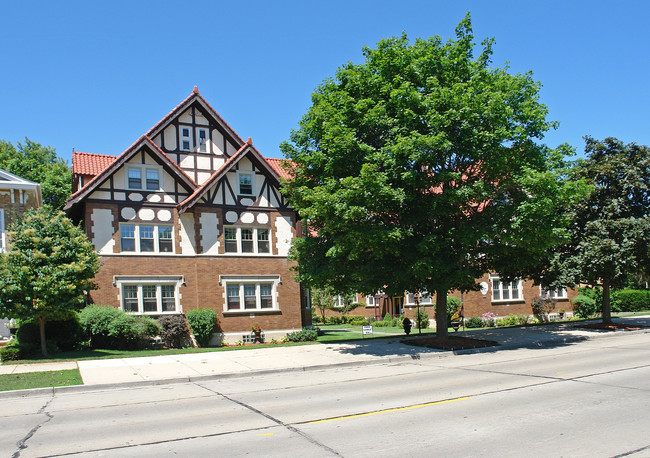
[{"x1": 552, "y1": 137, "x2": 650, "y2": 323}]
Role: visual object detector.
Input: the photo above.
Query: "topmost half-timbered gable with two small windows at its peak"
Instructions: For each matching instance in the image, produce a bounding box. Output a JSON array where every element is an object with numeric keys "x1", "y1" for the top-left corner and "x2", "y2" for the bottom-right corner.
[{"x1": 147, "y1": 86, "x2": 244, "y2": 184}]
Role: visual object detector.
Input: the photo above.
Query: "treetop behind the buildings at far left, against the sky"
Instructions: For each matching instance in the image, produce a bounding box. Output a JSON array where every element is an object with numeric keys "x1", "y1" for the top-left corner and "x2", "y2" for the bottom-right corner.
[{"x1": 0, "y1": 138, "x2": 72, "y2": 208}]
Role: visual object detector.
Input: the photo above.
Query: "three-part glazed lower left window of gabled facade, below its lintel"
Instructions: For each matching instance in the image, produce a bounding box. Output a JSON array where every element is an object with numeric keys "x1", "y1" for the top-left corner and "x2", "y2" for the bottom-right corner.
[{"x1": 121, "y1": 282, "x2": 178, "y2": 314}]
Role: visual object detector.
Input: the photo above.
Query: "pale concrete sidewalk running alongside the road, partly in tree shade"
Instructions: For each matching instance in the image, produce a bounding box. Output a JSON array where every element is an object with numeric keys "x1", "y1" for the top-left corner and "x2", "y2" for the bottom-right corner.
[{"x1": 0, "y1": 317, "x2": 650, "y2": 390}]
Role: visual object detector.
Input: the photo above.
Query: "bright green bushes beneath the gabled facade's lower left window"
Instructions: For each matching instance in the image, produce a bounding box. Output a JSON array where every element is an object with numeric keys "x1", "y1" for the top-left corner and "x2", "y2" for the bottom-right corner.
[{"x1": 79, "y1": 305, "x2": 160, "y2": 350}]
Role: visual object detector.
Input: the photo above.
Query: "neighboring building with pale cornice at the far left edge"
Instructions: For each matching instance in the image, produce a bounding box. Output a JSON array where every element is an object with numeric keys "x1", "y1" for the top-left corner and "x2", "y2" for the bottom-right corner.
[{"x1": 0, "y1": 169, "x2": 43, "y2": 337}]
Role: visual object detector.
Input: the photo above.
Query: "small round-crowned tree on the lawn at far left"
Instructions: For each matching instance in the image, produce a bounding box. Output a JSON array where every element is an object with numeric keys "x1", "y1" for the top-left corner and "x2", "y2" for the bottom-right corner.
[{"x1": 0, "y1": 205, "x2": 99, "y2": 355}]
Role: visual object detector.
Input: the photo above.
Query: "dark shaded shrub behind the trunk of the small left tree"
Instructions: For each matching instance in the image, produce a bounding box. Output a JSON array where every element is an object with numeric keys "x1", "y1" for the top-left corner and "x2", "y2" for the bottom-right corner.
[{"x1": 16, "y1": 312, "x2": 85, "y2": 353}]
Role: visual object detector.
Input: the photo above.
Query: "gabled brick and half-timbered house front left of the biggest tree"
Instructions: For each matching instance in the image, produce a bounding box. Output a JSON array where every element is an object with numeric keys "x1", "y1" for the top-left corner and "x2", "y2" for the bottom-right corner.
[{"x1": 65, "y1": 87, "x2": 311, "y2": 343}]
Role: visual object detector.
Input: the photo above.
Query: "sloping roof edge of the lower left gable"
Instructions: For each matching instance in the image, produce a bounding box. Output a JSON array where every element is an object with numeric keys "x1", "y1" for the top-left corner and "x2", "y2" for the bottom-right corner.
[{"x1": 63, "y1": 135, "x2": 197, "y2": 210}]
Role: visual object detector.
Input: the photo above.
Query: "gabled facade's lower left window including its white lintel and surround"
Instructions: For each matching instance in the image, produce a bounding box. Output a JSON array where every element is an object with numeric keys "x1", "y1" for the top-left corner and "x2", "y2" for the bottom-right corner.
[{"x1": 115, "y1": 276, "x2": 183, "y2": 315}]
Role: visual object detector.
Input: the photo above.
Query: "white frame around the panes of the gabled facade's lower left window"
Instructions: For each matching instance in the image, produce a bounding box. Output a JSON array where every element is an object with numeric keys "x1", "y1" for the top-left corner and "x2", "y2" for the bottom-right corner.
[{"x1": 113, "y1": 275, "x2": 185, "y2": 315}]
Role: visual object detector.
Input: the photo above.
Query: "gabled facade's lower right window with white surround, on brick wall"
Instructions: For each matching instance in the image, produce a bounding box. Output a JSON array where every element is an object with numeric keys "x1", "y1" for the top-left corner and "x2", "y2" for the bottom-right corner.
[{"x1": 220, "y1": 276, "x2": 280, "y2": 312}]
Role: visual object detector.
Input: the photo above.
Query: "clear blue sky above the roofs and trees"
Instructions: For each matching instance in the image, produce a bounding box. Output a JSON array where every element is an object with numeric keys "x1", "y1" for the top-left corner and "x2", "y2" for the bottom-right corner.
[{"x1": 0, "y1": 0, "x2": 650, "y2": 162}]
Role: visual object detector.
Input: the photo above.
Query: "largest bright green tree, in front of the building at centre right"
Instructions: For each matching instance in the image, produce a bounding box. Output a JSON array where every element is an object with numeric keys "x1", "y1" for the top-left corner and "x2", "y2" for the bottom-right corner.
[{"x1": 281, "y1": 15, "x2": 576, "y2": 335}]
